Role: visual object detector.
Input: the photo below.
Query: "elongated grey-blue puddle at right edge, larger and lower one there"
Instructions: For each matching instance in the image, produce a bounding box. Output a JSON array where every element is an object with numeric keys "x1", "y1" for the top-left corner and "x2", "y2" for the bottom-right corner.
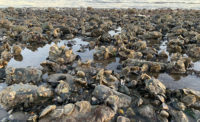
[{"x1": 157, "y1": 73, "x2": 200, "y2": 90}]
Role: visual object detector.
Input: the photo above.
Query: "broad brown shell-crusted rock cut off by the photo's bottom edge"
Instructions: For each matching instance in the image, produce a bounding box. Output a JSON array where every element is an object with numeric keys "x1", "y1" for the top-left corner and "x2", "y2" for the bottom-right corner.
[{"x1": 39, "y1": 101, "x2": 115, "y2": 122}]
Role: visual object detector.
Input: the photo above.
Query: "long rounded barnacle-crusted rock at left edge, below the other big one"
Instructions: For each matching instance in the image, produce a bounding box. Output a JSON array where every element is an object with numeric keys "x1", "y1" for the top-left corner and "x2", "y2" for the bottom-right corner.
[{"x1": 0, "y1": 84, "x2": 53, "y2": 108}]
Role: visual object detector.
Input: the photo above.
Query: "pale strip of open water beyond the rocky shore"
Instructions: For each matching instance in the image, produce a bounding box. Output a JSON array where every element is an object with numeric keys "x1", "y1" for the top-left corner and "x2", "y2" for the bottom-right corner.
[{"x1": 0, "y1": 0, "x2": 200, "y2": 9}]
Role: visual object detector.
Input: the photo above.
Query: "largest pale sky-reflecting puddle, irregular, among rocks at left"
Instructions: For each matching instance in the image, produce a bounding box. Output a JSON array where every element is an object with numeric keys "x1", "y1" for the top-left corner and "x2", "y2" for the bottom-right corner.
[{"x1": 8, "y1": 38, "x2": 94, "y2": 68}]
